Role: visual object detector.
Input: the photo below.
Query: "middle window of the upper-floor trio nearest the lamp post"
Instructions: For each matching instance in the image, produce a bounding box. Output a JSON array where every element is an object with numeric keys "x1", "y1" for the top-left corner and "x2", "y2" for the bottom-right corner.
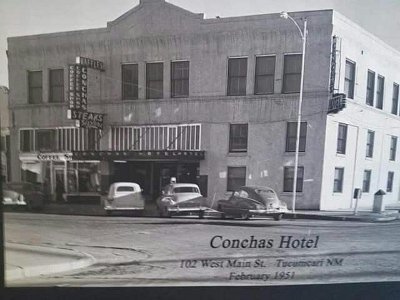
[{"x1": 254, "y1": 56, "x2": 275, "y2": 95}]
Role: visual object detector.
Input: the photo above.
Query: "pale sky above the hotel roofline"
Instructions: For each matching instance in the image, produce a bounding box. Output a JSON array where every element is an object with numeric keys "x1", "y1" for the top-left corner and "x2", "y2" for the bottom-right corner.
[{"x1": 0, "y1": 0, "x2": 400, "y2": 86}]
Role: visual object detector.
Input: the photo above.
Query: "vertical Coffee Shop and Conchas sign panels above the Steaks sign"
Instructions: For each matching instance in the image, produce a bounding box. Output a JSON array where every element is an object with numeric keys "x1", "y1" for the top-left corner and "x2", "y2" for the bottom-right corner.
[{"x1": 68, "y1": 64, "x2": 87, "y2": 111}]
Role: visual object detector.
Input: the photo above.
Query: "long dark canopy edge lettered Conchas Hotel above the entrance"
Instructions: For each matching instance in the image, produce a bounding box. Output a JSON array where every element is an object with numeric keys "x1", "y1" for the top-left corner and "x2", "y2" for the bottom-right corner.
[{"x1": 72, "y1": 150, "x2": 204, "y2": 160}]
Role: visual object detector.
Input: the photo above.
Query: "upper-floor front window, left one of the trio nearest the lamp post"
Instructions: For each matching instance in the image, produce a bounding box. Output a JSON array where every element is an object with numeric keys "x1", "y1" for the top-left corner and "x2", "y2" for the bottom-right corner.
[{"x1": 228, "y1": 57, "x2": 247, "y2": 96}]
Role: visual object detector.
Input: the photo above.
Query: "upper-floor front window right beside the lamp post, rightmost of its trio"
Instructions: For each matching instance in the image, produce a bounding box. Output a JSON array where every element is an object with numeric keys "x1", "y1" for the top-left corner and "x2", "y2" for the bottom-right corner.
[{"x1": 282, "y1": 54, "x2": 302, "y2": 94}]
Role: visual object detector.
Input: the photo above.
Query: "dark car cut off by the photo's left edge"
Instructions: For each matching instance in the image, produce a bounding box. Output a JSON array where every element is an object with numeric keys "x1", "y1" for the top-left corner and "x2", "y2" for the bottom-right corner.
[{"x1": 3, "y1": 182, "x2": 45, "y2": 210}]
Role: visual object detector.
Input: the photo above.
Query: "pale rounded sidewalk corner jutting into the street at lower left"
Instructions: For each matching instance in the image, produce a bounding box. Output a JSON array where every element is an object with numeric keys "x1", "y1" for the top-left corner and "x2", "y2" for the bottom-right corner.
[{"x1": 4, "y1": 243, "x2": 95, "y2": 284}]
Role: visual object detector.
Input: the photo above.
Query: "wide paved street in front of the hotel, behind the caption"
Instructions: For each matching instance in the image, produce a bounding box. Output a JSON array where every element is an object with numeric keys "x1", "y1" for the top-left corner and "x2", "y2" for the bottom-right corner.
[{"x1": 4, "y1": 213, "x2": 400, "y2": 286}]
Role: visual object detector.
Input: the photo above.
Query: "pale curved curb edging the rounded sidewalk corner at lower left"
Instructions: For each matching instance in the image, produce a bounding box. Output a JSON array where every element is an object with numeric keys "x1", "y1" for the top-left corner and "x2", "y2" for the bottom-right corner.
[{"x1": 4, "y1": 243, "x2": 95, "y2": 283}]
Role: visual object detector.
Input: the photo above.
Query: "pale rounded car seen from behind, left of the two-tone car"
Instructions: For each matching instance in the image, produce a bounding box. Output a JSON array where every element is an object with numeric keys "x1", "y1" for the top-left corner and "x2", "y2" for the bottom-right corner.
[{"x1": 104, "y1": 182, "x2": 144, "y2": 215}]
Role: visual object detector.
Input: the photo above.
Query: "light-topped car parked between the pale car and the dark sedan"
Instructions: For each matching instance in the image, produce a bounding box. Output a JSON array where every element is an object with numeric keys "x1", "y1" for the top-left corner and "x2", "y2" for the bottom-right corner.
[{"x1": 156, "y1": 183, "x2": 210, "y2": 218}]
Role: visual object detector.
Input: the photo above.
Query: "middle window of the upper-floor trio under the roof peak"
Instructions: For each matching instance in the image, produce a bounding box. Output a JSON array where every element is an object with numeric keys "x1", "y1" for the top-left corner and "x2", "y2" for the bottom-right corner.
[{"x1": 146, "y1": 63, "x2": 164, "y2": 99}]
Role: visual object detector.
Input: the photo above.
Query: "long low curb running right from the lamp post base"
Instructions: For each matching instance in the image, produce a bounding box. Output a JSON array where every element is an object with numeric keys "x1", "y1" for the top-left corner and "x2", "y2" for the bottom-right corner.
[{"x1": 284, "y1": 213, "x2": 399, "y2": 223}]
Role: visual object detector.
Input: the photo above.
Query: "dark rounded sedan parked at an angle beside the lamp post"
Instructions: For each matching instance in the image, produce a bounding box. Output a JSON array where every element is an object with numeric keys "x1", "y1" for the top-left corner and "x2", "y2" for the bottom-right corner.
[{"x1": 217, "y1": 186, "x2": 288, "y2": 221}]
